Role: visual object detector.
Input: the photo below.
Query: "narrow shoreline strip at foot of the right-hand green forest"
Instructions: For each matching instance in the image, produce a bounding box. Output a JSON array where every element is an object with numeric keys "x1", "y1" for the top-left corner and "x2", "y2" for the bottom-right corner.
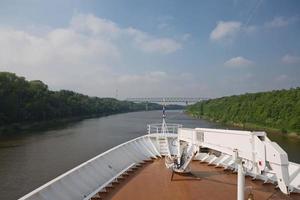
[{"x1": 185, "y1": 111, "x2": 300, "y2": 139}]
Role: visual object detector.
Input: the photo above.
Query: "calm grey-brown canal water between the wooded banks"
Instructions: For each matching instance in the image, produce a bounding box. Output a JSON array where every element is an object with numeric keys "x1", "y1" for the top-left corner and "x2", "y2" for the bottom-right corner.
[{"x1": 0, "y1": 111, "x2": 300, "y2": 200}]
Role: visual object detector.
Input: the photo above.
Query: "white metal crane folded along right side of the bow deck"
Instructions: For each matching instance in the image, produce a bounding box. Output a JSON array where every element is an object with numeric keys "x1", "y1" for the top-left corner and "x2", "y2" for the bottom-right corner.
[{"x1": 178, "y1": 128, "x2": 300, "y2": 194}]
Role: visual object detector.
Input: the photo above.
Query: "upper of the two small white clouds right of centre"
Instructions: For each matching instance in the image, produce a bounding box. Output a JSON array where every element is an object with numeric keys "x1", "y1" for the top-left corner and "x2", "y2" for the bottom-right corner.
[{"x1": 210, "y1": 21, "x2": 242, "y2": 41}]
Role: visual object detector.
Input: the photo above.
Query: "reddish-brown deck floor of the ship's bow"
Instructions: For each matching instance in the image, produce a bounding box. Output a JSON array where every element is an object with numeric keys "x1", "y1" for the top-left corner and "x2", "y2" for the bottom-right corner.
[{"x1": 101, "y1": 159, "x2": 300, "y2": 200}]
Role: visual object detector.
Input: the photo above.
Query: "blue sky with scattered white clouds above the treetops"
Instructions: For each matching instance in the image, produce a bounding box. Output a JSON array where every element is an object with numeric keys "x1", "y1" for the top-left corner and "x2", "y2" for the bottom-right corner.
[{"x1": 0, "y1": 0, "x2": 300, "y2": 99}]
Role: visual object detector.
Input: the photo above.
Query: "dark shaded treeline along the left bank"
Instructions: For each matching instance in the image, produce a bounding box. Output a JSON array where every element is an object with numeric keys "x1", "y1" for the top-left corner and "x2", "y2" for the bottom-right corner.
[{"x1": 0, "y1": 72, "x2": 161, "y2": 126}]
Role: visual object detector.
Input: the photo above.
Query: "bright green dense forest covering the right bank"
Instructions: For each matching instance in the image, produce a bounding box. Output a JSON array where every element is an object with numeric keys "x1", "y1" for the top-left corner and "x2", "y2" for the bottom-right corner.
[{"x1": 187, "y1": 87, "x2": 300, "y2": 134}]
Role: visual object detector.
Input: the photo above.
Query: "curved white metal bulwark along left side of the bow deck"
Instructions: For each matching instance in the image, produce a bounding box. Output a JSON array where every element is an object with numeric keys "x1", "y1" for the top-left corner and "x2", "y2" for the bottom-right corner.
[{"x1": 20, "y1": 134, "x2": 169, "y2": 200}]
